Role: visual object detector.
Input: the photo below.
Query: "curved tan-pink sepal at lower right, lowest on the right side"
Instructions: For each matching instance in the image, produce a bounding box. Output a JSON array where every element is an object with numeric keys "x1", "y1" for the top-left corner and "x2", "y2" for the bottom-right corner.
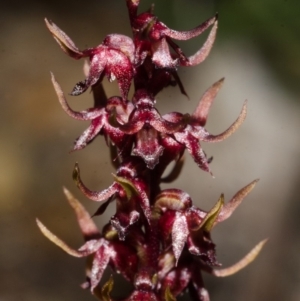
[{"x1": 210, "y1": 239, "x2": 268, "y2": 277}]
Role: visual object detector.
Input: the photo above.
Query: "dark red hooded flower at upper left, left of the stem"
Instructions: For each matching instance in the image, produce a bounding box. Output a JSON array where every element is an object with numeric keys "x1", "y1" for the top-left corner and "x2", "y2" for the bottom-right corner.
[{"x1": 45, "y1": 19, "x2": 135, "y2": 100}]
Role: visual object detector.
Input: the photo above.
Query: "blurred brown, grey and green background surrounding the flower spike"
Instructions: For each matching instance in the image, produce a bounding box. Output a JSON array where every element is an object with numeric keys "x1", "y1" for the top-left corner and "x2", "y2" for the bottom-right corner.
[{"x1": 0, "y1": 0, "x2": 300, "y2": 301}]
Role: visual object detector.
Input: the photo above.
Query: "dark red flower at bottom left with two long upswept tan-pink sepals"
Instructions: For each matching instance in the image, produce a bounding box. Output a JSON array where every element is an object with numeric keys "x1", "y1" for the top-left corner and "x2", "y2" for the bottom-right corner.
[{"x1": 37, "y1": 189, "x2": 138, "y2": 292}]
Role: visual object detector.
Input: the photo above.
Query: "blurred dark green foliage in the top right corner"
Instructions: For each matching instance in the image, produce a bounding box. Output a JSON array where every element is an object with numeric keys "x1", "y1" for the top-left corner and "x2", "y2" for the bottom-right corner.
[{"x1": 215, "y1": 0, "x2": 300, "y2": 96}]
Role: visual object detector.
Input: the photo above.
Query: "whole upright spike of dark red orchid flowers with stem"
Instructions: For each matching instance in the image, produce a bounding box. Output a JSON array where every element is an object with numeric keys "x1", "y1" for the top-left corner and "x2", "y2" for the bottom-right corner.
[{"x1": 37, "y1": 0, "x2": 265, "y2": 301}]
